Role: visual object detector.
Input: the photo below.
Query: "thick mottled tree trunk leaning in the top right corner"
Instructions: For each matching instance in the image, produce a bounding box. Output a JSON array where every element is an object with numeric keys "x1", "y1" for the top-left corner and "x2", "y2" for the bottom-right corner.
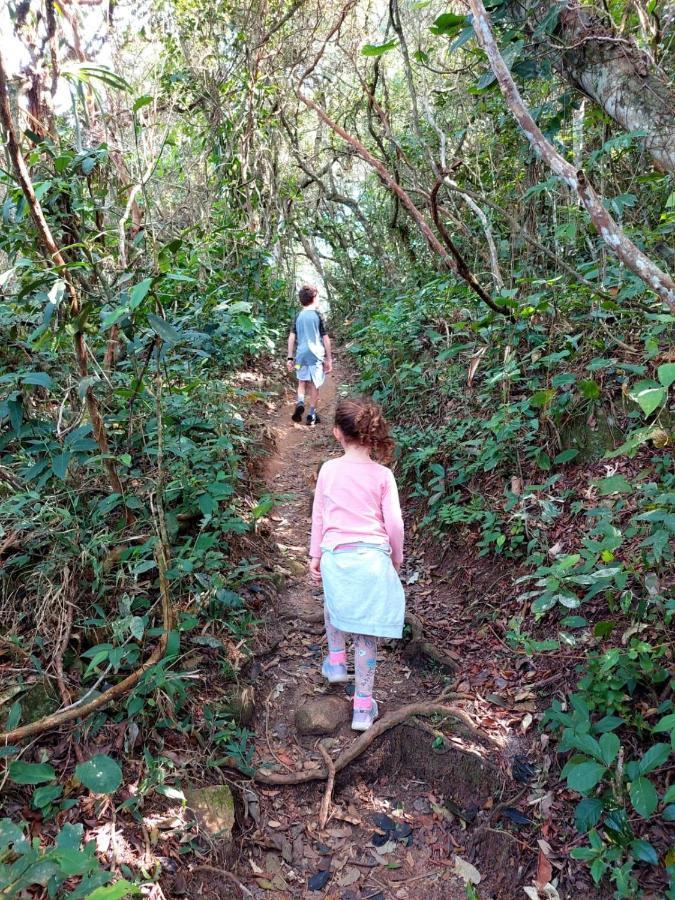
[{"x1": 510, "y1": 0, "x2": 675, "y2": 174}]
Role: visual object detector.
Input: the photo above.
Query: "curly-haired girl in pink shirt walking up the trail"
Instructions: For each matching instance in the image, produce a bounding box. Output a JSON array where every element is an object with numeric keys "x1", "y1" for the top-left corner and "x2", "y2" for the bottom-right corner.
[{"x1": 310, "y1": 400, "x2": 405, "y2": 731}]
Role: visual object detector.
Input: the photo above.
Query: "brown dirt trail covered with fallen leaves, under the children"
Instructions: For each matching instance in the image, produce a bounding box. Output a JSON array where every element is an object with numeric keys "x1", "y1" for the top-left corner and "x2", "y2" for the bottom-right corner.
[{"x1": 237, "y1": 361, "x2": 532, "y2": 900}]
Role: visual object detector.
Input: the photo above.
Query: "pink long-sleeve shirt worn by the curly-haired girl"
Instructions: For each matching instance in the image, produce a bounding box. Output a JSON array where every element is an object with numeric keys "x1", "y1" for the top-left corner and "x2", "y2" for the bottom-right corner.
[{"x1": 310, "y1": 456, "x2": 403, "y2": 567}]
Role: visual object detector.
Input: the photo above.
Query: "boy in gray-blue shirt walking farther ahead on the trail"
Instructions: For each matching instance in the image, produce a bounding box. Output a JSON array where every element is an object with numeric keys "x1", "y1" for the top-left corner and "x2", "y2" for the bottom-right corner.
[{"x1": 286, "y1": 285, "x2": 333, "y2": 427}]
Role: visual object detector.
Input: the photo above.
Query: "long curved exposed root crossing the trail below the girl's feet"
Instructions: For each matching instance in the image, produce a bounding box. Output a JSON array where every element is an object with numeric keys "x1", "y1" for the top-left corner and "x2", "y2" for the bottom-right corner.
[{"x1": 248, "y1": 691, "x2": 489, "y2": 784}]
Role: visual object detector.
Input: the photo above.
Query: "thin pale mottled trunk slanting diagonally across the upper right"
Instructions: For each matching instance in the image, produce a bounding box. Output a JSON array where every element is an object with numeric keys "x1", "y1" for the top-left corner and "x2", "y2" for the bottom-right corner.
[{"x1": 468, "y1": 0, "x2": 675, "y2": 312}]
